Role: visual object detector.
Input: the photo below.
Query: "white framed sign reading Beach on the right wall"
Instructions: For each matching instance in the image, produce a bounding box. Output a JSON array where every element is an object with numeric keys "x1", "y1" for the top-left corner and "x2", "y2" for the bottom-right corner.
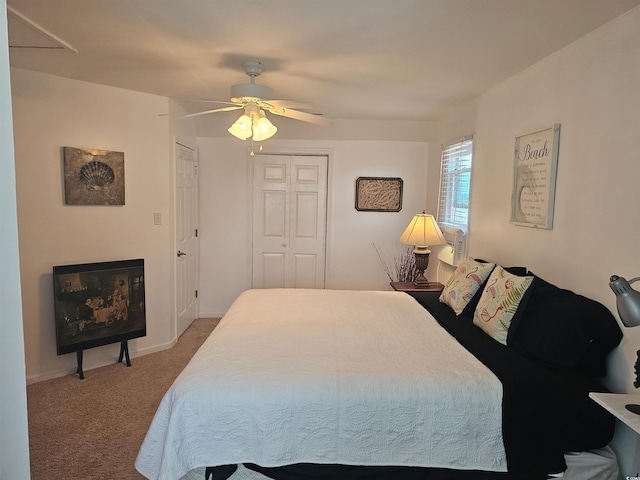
[{"x1": 511, "y1": 124, "x2": 560, "y2": 230}]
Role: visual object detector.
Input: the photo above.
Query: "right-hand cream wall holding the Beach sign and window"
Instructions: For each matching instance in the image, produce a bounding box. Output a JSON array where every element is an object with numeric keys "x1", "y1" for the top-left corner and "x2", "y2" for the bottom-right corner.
[{"x1": 428, "y1": 7, "x2": 640, "y2": 477}]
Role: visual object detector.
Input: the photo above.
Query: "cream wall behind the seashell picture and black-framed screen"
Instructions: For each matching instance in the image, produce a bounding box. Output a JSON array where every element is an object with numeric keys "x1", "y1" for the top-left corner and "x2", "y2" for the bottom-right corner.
[{"x1": 11, "y1": 69, "x2": 175, "y2": 382}]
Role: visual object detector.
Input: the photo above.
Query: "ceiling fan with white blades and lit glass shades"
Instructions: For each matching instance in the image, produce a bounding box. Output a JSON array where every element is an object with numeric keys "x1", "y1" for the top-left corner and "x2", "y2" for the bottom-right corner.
[{"x1": 182, "y1": 60, "x2": 331, "y2": 141}]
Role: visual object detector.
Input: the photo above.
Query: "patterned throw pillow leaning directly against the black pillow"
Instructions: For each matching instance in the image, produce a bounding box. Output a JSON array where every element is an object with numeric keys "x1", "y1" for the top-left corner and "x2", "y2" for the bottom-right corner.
[{"x1": 473, "y1": 265, "x2": 533, "y2": 345}]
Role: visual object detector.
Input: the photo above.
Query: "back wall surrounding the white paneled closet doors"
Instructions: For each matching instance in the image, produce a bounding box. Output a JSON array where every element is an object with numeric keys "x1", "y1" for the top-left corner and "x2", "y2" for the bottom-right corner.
[{"x1": 199, "y1": 138, "x2": 428, "y2": 316}]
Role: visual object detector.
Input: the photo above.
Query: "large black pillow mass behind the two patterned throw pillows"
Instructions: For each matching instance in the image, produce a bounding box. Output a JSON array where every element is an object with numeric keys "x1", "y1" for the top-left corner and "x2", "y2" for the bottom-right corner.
[{"x1": 507, "y1": 275, "x2": 622, "y2": 377}]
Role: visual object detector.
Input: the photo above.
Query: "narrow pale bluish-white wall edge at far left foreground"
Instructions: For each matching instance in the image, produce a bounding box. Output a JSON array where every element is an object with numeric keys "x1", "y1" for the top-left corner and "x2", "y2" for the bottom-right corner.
[{"x1": 0, "y1": 0, "x2": 30, "y2": 479}]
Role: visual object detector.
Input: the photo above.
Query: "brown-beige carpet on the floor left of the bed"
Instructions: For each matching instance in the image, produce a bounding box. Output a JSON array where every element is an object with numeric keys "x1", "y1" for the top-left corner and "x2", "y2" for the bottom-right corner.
[{"x1": 27, "y1": 319, "x2": 218, "y2": 480}]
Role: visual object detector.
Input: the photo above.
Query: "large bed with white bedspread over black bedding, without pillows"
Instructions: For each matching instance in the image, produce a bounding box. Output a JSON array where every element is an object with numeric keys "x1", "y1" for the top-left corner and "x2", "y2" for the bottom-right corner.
[{"x1": 136, "y1": 266, "x2": 614, "y2": 480}]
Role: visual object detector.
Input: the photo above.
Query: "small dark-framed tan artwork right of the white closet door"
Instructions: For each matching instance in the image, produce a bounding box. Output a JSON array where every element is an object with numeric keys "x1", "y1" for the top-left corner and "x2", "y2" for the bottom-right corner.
[{"x1": 356, "y1": 177, "x2": 403, "y2": 212}]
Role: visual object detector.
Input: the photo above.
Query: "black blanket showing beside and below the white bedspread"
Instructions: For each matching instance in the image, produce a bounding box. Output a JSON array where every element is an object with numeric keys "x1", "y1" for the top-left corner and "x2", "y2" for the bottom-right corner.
[{"x1": 207, "y1": 292, "x2": 615, "y2": 480}]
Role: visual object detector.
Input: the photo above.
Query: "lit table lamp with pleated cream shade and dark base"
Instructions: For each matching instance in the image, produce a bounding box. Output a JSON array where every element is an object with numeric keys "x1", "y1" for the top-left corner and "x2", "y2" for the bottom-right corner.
[{"x1": 399, "y1": 210, "x2": 447, "y2": 287}]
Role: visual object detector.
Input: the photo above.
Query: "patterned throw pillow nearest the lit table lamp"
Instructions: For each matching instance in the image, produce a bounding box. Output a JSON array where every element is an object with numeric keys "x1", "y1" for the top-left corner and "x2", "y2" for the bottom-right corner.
[{"x1": 440, "y1": 257, "x2": 495, "y2": 315}]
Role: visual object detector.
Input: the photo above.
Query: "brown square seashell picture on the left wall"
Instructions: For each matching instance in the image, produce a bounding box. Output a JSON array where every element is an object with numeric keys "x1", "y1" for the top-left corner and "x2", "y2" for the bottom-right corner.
[{"x1": 63, "y1": 147, "x2": 124, "y2": 205}]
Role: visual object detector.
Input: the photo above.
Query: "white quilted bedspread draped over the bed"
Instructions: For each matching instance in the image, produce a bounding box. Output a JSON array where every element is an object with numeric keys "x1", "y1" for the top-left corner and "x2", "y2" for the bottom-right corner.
[{"x1": 136, "y1": 289, "x2": 506, "y2": 480}]
